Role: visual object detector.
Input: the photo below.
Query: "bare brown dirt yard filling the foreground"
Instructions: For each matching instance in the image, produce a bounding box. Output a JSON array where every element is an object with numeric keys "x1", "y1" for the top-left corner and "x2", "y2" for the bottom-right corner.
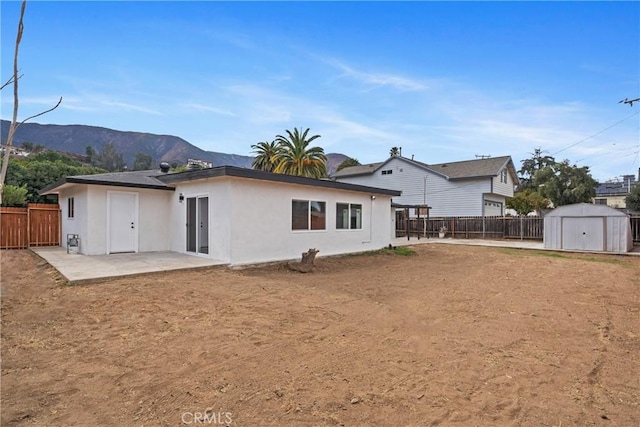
[{"x1": 0, "y1": 245, "x2": 640, "y2": 426}]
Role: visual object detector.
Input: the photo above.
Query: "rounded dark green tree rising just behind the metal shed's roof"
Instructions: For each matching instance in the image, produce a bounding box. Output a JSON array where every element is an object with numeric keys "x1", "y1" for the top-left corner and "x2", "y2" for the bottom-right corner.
[{"x1": 532, "y1": 160, "x2": 598, "y2": 207}]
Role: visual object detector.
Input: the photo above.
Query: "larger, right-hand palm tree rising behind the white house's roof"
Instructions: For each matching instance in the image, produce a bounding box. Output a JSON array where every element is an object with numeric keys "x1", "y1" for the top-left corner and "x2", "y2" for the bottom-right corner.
[{"x1": 272, "y1": 128, "x2": 327, "y2": 178}]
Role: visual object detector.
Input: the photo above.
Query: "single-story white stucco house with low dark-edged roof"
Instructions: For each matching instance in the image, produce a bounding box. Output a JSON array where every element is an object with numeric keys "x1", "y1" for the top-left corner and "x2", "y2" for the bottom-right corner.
[{"x1": 41, "y1": 166, "x2": 400, "y2": 265}]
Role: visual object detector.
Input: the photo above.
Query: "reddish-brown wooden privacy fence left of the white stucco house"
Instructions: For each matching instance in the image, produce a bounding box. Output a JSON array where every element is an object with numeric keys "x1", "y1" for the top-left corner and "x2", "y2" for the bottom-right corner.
[{"x1": 0, "y1": 203, "x2": 60, "y2": 249}]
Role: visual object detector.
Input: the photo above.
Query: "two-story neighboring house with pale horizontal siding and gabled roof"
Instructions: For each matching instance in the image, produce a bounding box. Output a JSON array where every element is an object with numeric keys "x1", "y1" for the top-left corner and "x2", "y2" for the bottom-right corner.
[{"x1": 332, "y1": 156, "x2": 518, "y2": 217}]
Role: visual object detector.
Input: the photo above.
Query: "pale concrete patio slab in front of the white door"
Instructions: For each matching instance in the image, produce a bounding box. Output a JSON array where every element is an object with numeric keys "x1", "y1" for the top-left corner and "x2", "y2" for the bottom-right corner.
[{"x1": 31, "y1": 247, "x2": 226, "y2": 284}]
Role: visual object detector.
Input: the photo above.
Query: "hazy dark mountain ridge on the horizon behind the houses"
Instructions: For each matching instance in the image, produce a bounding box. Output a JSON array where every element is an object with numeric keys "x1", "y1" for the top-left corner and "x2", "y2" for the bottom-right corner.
[{"x1": 0, "y1": 120, "x2": 347, "y2": 174}]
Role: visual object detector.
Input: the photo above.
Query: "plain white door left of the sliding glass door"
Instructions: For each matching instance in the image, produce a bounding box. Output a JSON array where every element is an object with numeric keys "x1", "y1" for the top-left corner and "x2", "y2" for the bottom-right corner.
[{"x1": 107, "y1": 191, "x2": 138, "y2": 254}]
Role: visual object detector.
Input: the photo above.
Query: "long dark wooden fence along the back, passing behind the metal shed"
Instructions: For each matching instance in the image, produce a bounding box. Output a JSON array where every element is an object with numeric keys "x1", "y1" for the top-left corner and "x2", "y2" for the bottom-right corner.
[{"x1": 396, "y1": 211, "x2": 640, "y2": 245}]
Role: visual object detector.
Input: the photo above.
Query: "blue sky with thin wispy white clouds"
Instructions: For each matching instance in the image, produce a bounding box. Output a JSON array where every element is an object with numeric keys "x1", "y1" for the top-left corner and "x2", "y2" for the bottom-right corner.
[{"x1": 0, "y1": 1, "x2": 640, "y2": 180}]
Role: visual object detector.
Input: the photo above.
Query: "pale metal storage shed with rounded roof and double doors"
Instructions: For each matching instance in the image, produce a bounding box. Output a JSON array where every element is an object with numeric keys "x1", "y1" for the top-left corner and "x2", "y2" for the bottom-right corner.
[{"x1": 544, "y1": 203, "x2": 633, "y2": 252}]
